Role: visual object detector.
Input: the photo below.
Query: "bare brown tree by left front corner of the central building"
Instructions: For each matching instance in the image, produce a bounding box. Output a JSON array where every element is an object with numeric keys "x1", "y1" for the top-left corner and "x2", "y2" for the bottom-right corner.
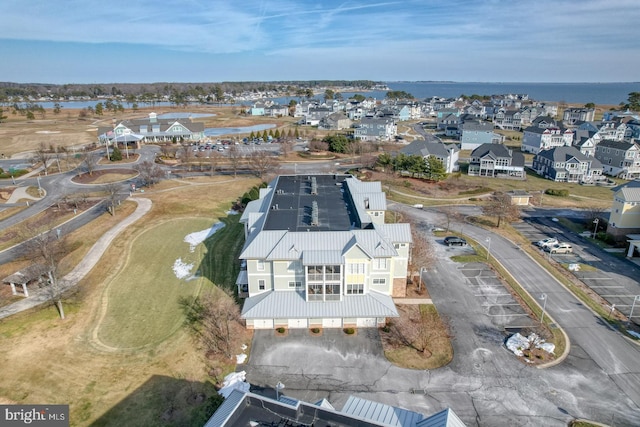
[{"x1": 180, "y1": 289, "x2": 242, "y2": 358}]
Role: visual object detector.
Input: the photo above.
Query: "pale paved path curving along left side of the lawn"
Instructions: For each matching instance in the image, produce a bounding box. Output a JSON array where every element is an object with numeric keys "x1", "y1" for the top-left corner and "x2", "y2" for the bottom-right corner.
[{"x1": 0, "y1": 197, "x2": 151, "y2": 319}]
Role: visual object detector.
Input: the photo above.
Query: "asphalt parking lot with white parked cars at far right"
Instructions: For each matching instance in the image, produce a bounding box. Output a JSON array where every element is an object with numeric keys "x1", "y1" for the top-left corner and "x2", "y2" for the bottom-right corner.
[{"x1": 513, "y1": 218, "x2": 640, "y2": 324}]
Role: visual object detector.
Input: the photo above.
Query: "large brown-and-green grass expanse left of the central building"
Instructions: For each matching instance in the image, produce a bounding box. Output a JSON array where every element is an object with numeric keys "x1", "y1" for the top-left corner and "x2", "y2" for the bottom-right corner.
[{"x1": 0, "y1": 177, "x2": 257, "y2": 427}]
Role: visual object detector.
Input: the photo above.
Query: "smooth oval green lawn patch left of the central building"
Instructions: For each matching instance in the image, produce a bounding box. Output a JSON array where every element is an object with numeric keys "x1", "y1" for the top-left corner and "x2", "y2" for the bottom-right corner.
[{"x1": 98, "y1": 218, "x2": 218, "y2": 348}]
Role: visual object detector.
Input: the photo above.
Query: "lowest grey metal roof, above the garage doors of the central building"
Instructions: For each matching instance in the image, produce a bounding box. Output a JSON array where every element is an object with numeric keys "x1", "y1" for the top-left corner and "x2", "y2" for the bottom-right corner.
[{"x1": 242, "y1": 291, "x2": 398, "y2": 319}]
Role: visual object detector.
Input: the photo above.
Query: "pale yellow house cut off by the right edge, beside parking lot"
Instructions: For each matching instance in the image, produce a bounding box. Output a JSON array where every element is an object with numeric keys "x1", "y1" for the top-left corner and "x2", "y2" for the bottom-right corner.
[{"x1": 607, "y1": 179, "x2": 640, "y2": 241}]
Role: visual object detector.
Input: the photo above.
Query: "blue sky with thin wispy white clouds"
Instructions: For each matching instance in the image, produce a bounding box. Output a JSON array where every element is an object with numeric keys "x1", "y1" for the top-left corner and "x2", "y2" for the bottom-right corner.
[{"x1": 0, "y1": 0, "x2": 640, "y2": 83}]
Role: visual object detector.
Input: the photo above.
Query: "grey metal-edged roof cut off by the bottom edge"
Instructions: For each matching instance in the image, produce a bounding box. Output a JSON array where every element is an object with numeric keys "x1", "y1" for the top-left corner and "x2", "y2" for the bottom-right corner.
[{"x1": 204, "y1": 392, "x2": 466, "y2": 427}]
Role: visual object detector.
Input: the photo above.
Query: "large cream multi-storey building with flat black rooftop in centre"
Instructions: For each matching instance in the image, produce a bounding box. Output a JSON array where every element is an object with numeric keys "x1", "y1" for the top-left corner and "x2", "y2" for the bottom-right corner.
[{"x1": 236, "y1": 174, "x2": 412, "y2": 329}]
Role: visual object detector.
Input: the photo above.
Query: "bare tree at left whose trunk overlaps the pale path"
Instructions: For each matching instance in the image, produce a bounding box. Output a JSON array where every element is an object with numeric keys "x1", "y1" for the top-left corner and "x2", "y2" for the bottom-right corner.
[{"x1": 23, "y1": 230, "x2": 68, "y2": 319}]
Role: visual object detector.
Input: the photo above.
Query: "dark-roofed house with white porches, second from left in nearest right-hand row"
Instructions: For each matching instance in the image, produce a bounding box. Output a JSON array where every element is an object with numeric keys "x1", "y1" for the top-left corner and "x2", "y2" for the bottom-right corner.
[{"x1": 468, "y1": 144, "x2": 525, "y2": 179}]
